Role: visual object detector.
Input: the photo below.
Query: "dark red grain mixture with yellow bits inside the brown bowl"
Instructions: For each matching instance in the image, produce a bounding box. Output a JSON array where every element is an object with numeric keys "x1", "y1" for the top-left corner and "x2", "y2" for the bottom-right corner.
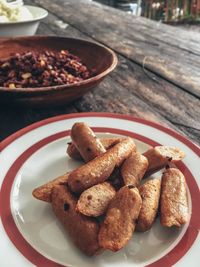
[{"x1": 0, "y1": 50, "x2": 93, "y2": 89}]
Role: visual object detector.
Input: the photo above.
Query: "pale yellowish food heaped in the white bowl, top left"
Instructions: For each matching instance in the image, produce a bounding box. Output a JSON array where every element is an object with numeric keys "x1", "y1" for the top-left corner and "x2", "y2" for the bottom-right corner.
[{"x1": 0, "y1": 0, "x2": 33, "y2": 23}]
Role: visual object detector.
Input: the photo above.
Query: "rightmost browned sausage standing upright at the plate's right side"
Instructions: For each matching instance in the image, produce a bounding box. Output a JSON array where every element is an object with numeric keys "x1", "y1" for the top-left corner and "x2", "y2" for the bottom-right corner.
[{"x1": 160, "y1": 168, "x2": 189, "y2": 227}]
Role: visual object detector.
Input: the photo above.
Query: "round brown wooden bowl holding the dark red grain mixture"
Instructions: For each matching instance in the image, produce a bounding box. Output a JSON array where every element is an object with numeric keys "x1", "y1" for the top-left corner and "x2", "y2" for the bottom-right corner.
[{"x1": 0, "y1": 36, "x2": 118, "y2": 107}]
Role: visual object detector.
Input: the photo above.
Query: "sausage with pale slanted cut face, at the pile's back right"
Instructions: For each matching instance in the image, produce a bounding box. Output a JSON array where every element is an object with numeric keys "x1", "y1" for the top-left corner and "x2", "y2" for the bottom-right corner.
[{"x1": 143, "y1": 146, "x2": 185, "y2": 177}]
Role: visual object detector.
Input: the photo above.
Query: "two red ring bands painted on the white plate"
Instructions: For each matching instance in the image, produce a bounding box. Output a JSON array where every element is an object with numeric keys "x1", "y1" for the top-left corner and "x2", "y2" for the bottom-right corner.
[{"x1": 0, "y1": 113, "x2": 200, "y2": 267}]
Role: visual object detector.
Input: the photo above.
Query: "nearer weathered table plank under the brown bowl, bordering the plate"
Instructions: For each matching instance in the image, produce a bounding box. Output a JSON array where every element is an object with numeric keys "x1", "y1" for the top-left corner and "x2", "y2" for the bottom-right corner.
[{"x1": 0, "y1": 8, "x2": 200, "y2": 143}]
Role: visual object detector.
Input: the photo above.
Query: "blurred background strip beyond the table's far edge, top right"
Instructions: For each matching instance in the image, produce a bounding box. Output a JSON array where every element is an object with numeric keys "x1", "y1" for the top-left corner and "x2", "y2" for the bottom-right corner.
[{"x1": 95, "y1": 0, "x2": 200, "y2": 25}]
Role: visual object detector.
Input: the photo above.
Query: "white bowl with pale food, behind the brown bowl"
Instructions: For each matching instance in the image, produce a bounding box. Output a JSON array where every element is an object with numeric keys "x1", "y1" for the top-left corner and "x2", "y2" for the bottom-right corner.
[{"x1": 0, "y1": 5, "x2": 48, "y2": 37}]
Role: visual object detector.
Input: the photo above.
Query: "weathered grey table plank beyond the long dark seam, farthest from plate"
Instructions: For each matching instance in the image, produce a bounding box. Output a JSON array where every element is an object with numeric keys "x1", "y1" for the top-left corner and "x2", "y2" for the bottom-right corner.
[{"x1": 29, "y1": 0, "x2": 200, "y2": 97}]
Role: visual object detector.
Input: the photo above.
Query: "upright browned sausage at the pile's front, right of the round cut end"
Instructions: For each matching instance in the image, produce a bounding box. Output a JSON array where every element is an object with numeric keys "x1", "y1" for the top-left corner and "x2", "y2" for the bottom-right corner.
[{"x1": 99, "y1": 186, "x2": 142, "y2": 251}]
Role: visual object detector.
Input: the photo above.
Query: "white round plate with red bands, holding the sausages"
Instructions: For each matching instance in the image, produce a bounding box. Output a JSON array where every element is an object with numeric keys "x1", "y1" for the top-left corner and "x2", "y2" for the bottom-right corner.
[{"x1": 0, "y1": 113, "x2": 200, "y2": 267}]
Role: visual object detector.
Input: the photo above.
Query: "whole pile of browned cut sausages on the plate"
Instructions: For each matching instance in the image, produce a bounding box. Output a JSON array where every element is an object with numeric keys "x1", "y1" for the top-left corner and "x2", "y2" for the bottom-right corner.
[{"x1": 33, "y1": 122, "x2": 189, "y2": 256}]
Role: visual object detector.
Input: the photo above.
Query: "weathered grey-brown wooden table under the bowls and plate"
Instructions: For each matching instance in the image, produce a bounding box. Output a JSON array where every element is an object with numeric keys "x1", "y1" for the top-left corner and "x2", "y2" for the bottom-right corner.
[{"x1": 0, "y1": 0, "x2": 200, "y2": 144}]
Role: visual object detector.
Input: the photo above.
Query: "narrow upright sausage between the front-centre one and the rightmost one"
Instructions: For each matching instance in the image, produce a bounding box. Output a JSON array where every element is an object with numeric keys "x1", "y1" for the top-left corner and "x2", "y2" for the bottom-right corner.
[{"x1": 136, "y1": 179, "x2": 161, "y2": 232}]
